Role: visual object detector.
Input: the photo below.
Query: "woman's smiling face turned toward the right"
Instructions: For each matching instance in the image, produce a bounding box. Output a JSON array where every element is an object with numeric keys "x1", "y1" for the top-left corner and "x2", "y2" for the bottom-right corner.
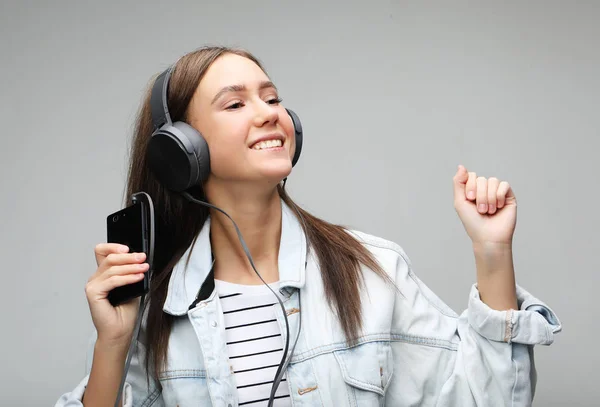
[{"x1": 188, "y1": 54, "x2": 295, "y2": 190}]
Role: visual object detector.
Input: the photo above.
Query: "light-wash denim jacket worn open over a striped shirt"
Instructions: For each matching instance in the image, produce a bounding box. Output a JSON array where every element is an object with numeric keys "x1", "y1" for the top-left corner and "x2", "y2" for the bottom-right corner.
[{"x1": 56, "y1": 202, "x2": 561, "y2": 407}]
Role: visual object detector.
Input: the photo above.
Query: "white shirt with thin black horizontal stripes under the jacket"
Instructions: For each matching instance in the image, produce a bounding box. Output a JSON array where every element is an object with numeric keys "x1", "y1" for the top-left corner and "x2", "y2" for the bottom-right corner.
[{"x1": 215, "y1": 279, "x2": 291, "y2": 407}]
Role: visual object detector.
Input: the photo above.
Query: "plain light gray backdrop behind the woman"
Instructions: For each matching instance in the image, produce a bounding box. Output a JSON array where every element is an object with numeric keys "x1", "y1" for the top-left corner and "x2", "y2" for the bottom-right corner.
[{"x1": 0, "y1": 0, "x2": 600, "y2": 406}]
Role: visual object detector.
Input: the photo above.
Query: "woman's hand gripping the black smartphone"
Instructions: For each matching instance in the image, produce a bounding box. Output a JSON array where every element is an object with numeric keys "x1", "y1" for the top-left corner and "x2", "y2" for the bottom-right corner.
[{"x1": 85, "y1": 243, "x2": 149, "y2": 348}]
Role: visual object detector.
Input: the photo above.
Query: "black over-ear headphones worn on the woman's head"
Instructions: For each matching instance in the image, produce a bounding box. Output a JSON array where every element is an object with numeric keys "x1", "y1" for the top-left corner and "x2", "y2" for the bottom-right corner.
[{"x1": 147, "y1": 65, "x2": 302, "y2": 192}]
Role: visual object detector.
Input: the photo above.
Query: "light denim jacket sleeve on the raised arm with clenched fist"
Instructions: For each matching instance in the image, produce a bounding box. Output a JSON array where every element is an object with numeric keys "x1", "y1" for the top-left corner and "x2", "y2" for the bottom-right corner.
[{"x1": 386, "y1": 253, "x2": 562, "y2": 407}]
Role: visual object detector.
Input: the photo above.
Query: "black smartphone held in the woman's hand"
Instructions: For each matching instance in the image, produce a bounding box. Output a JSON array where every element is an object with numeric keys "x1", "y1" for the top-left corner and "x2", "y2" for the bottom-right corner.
[{"x1": 106, "y1": 201, "x2": 150, "y2": 306}]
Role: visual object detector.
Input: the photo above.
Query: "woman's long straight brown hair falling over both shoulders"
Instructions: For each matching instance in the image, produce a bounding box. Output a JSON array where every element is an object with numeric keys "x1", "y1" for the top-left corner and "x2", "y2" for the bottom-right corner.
[{"x1": 125, "y1": 47, "x2": 391, "y2": 377}]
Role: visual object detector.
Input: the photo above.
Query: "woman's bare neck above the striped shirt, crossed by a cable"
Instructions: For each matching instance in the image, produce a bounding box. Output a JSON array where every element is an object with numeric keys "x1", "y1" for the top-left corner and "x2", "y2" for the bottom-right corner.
[{"x1": 209, "y1": 186, "x2": 281, "y2": 284}]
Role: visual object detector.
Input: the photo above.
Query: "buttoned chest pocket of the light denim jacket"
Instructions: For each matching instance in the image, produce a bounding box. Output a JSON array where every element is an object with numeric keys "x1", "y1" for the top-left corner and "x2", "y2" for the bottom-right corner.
[{"x1": 334, "y1": 342, "x2": 394, "y2": 407}]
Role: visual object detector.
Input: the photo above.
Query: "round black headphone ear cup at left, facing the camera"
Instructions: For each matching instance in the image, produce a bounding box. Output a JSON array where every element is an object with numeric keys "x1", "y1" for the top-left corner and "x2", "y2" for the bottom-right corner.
[{"x1": 147, "y1": 122, "x2": 210, "y2": 192}]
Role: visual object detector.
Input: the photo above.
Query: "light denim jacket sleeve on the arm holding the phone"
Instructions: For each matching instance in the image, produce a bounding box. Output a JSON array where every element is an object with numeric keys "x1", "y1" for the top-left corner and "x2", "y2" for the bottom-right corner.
[{"x1": 55, "y1": 333, "x2": 164, "y2": 407}]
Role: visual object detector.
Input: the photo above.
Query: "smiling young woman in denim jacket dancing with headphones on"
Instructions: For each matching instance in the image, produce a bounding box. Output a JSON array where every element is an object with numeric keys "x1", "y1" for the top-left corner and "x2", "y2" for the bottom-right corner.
[{"x1": 57, "y1": 47, "x2": 561, "y2": 407}]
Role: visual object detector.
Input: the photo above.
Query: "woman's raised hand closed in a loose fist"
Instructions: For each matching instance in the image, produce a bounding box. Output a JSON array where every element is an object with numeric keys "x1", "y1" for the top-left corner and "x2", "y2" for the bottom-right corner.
[{"x1": 453, "y1": 165, "x2": 517, "y2": 248}]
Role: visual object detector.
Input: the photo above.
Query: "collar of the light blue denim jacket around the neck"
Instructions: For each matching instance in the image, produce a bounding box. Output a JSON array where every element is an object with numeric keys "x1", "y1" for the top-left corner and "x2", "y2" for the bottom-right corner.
[{"x1": 163, "y1": 200, "x2": 307, "y2": 315}]
